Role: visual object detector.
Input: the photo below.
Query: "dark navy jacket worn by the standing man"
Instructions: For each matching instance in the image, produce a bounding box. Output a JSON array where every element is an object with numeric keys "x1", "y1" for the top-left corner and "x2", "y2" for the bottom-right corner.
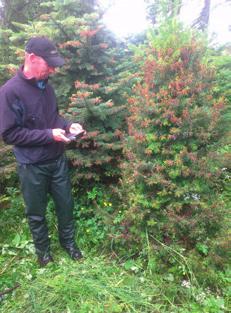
[{"x1": 0, "y1": 68, "x2": 71, "y2": 164}]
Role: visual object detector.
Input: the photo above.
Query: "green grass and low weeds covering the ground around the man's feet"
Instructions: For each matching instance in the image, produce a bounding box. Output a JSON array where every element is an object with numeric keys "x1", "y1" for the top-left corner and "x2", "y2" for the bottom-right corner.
[{"x1": 0, "y1": 189, "x2": 231, "y2": 313}]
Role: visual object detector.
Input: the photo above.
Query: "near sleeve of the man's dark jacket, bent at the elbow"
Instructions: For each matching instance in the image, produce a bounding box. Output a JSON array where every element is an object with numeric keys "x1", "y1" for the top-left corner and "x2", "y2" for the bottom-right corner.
[{"x1": 0, "y1": 88, "x2": 54, "y2": 146}]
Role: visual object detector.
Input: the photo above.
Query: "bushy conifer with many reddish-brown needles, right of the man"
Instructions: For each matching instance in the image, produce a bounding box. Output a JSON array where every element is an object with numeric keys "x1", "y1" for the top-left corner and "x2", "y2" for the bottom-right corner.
[{"x1": 117, "y1": 21, "x2": 227, "y2": 255}]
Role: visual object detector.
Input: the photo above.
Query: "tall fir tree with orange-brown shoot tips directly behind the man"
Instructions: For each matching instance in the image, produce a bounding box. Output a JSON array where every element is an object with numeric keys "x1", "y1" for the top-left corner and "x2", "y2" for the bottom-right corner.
[{"x1": 0, "y1": 0, "x2": 129, "y2": 185}]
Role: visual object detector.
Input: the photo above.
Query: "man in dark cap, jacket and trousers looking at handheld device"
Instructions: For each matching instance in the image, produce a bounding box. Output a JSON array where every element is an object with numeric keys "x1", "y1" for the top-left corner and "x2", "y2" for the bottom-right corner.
[{"x1": 0, "y1": 37, "x2": 84, "y2": 266}]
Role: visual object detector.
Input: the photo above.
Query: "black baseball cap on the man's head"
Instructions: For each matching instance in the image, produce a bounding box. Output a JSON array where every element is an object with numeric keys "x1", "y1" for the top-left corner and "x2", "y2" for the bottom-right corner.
[{"x1": 25, "y1": 36, "x2": 65, "y2": 67}]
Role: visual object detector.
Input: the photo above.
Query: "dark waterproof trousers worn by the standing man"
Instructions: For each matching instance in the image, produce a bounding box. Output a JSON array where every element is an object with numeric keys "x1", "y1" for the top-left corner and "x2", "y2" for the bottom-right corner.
[{"x1": 18, "y1": 156, "x2": 75, "y2": 256}]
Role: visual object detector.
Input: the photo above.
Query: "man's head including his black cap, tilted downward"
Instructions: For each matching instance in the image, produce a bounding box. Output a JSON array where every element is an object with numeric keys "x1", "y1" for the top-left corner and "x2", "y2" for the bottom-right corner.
[{"x1": 24, "y1": 37, "x2": 64, "y2": 80}]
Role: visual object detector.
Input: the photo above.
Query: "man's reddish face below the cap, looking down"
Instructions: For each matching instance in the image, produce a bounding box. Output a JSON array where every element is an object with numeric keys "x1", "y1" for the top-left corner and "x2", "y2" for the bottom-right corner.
[{"x1": 31, "y1": 55, "x2": 55, "y2": 80}]
